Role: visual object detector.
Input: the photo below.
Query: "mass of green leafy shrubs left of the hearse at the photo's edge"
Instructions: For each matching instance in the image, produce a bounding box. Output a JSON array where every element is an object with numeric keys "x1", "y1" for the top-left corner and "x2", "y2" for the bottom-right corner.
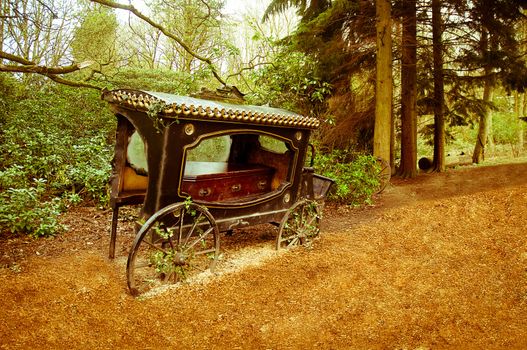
[{"x1": 0, "y1": 80, "x2": 115, "y2": 236}]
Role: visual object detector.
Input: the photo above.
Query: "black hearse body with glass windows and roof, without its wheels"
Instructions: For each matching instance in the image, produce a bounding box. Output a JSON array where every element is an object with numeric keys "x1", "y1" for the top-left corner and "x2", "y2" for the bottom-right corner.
[{"x1": 103, "y1": 90, "x2": 318, "y2": 237}]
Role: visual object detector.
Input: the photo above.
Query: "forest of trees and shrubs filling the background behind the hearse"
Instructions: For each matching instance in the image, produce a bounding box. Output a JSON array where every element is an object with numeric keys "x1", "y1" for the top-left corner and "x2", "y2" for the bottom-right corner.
[{"x1": 0, "y1": 0, "x2": 527, "y2": 237}]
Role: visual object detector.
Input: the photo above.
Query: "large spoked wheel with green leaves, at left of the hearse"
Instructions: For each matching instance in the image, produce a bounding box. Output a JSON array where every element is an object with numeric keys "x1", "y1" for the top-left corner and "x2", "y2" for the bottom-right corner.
[{"x1": 126, "y1": 203, "x2": 220, "y2": 295}]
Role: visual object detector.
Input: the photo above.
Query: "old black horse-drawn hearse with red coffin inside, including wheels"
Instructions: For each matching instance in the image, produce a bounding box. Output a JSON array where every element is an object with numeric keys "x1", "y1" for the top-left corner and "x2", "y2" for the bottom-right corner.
[{"x1": 102, "y1": 89, "x2": 333, "y2": 295}]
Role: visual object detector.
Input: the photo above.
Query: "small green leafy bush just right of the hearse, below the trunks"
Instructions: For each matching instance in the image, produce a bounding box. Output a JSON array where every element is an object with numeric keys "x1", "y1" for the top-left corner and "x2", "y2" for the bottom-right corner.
[{"x1": 315, "y1": 150, "x2": 380, "y2": 206}]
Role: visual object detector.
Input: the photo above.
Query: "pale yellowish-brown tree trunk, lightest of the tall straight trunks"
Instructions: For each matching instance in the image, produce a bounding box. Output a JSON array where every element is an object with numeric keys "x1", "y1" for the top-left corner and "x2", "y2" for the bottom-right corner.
[{"x1": 373, "y1": 0, "x2": 393, "y2": 162}]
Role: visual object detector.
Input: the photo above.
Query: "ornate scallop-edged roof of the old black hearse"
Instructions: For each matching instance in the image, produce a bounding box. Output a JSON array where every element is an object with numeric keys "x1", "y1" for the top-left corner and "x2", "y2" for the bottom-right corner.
[{"x1": 102, "y1": 89, "x2": 320, "y2": 129}]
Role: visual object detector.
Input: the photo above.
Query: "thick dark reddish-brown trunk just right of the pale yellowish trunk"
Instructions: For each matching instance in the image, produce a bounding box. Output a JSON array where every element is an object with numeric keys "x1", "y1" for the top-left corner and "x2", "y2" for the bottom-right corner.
[{"x1": 398, "y1": 0, "x2": 417, "y2": 178}]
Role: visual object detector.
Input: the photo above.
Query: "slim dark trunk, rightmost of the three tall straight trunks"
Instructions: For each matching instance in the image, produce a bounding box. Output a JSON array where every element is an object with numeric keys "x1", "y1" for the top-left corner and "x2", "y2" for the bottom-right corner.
[{"x1": 432, "y1": 0, "x2": 446, "y2": 172}]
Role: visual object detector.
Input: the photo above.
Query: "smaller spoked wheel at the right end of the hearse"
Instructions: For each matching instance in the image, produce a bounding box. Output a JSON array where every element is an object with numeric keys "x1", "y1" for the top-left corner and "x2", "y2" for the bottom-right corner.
[{"x1": 276, "y1": 199, "x2": 320, "y2": 249}]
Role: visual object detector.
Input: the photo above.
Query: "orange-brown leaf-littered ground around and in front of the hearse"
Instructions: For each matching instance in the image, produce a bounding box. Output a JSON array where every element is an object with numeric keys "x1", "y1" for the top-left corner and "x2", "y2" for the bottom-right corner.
[{"x1": 0, "y1": 164, "x2": 527, "y2": 349}]
